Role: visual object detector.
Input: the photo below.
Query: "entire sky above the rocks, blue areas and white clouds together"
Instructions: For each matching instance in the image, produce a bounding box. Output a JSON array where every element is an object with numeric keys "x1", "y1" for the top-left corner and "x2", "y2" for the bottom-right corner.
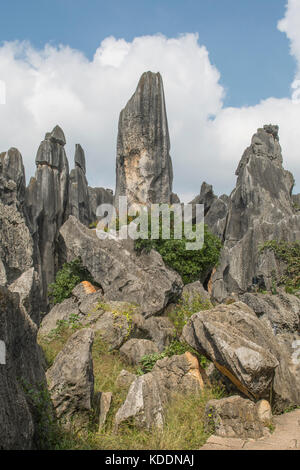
[{"x1": 0, "y1": 0, "x2": 300, "y2": 198}]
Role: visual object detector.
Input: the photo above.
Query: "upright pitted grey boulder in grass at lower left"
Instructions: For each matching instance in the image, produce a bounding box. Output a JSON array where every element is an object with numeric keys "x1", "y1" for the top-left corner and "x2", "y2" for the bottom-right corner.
[{"x1": 46, "y1": 328, "x2": 94, "y2": 429}]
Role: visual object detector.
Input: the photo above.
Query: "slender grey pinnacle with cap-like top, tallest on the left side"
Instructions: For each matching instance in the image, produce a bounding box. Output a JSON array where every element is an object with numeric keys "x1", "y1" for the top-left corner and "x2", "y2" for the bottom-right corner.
[{"x1": 26, "y1": 126, "x2": 69, "y2": 297}]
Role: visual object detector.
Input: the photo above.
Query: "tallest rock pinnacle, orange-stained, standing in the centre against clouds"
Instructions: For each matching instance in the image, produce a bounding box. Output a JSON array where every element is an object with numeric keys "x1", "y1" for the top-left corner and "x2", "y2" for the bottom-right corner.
[{"x1": 115, "y1": 72, "x2": 173, "y2": 205}]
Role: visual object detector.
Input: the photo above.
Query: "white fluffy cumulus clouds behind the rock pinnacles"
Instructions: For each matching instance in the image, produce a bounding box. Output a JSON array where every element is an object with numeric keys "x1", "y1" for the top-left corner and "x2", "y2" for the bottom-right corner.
[{"x1": 0, "y1": 0, "x2": 300, "y2": 201}]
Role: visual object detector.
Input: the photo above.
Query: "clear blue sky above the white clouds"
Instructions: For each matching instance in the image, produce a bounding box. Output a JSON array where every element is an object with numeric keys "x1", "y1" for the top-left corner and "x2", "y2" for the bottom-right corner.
[{"x1": 0, "y1": 0, "x2": 295, "y2": 106}]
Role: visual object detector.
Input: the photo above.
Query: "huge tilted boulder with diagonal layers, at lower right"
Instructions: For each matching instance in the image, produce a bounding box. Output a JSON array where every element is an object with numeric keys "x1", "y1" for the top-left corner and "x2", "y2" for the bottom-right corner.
[{"x1": 182, "y1": 302, "x2": 300, "y2": 412}]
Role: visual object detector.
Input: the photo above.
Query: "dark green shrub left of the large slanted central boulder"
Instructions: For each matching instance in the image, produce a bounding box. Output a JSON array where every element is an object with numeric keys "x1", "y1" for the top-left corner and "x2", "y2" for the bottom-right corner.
[{"x1": 48, "y1": 258, "x2": 94, "y2": 305}]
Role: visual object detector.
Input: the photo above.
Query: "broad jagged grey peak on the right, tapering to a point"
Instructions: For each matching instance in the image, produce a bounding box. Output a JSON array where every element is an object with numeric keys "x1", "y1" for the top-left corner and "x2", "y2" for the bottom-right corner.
[{"x1": 210, "y1": 125, "x2": 300, "y2": 301}]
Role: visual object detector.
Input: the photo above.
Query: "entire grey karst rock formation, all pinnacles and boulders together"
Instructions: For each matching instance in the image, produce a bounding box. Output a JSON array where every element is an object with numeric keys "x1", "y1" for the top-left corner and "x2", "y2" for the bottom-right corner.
[{"x1": 0, "y1": 72, "x2": 300, "y2": 450}]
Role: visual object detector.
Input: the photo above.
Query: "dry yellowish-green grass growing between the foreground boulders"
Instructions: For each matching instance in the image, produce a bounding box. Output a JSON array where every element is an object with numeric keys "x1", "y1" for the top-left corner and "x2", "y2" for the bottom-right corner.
[{"x1": 40, "y1": 327, "x2": 223, "y2": 450}]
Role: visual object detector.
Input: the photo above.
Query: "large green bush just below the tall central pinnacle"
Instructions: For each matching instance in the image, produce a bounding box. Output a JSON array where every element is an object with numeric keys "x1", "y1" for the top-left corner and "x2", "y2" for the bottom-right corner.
[{"x1": 135, "y1": 213, "x2": 222, "y2": 284}]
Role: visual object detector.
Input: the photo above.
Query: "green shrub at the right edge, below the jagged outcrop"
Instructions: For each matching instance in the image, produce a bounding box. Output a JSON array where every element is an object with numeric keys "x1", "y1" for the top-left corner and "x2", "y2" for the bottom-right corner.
[{"x1": 260, "y1": 240, "x2": 300, "y2": 294}]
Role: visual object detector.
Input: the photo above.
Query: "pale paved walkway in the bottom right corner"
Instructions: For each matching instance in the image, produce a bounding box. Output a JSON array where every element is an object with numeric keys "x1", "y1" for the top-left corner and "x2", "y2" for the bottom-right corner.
[{"x1": 200, "y1": 409, "x2": 300, "y2": 450}]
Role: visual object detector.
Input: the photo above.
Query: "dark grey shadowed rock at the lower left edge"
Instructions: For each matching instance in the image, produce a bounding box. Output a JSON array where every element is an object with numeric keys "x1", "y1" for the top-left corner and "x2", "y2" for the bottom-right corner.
[{"x1": 0, "y1": 287, "x2": 50, "y2": 450}]
